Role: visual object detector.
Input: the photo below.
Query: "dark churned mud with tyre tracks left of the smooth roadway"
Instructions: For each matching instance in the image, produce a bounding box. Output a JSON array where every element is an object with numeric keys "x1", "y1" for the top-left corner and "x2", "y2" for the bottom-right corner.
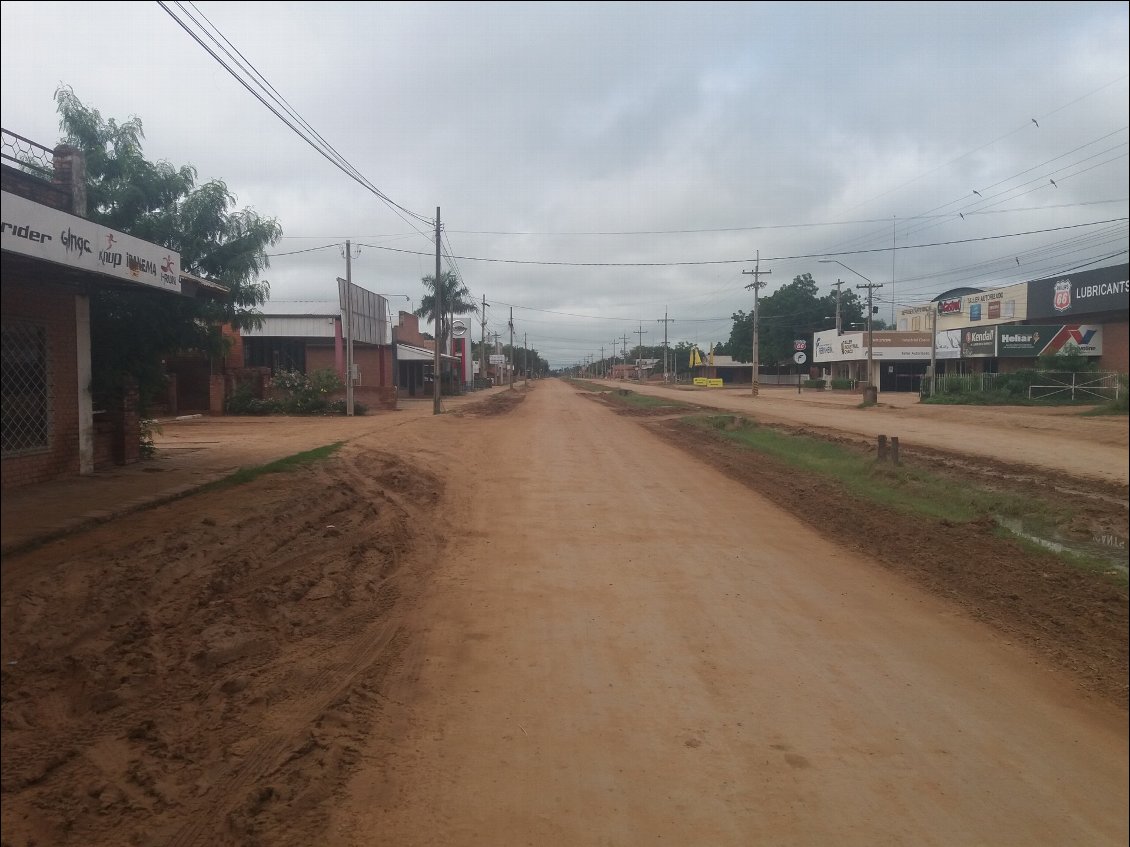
[{"x1": 0, "y1": 445, "x2": 442, "y2": 847}]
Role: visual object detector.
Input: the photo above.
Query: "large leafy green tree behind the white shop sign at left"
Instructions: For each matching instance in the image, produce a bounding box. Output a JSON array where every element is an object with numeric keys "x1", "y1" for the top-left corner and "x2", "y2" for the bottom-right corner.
[{"x1": 55, "y1": 86, "x2": 283, "y2": 408}]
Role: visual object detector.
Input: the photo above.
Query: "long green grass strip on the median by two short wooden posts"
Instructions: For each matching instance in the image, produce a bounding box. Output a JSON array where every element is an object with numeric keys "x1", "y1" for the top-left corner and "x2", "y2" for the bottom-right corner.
[{"x1": 686, "y1": 414, "x2": 1064, "y2": 524}]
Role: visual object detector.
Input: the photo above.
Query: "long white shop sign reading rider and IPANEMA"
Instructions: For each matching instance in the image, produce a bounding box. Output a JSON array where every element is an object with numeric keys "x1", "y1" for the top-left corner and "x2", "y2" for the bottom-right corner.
[{"x1": 0, "y1": 191, "x2": 181, "y2": 294}]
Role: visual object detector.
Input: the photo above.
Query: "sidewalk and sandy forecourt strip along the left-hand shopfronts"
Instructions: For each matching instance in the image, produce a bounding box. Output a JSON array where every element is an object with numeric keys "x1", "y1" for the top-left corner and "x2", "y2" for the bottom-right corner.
[{"x1": 0, "y1": 386, "x2": 506, "y2": 556}]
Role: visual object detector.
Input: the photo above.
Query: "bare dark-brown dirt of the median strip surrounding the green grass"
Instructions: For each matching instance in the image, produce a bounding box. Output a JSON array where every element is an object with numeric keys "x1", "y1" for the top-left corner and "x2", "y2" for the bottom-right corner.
[{"x1": 586, "y1": 394, "x2": 1130, "y2": 709}]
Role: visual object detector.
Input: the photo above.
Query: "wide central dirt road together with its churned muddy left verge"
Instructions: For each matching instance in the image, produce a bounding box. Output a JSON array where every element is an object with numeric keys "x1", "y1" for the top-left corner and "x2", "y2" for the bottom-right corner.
[{"x1": 0, "y1": 381, "x2": 1130, "y2": 847}]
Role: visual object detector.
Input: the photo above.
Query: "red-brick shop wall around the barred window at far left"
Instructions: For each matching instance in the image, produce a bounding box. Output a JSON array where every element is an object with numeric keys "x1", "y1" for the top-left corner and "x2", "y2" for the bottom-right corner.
[{"x1": 2, "y1": 278, "x2": 79, "y2": 488}]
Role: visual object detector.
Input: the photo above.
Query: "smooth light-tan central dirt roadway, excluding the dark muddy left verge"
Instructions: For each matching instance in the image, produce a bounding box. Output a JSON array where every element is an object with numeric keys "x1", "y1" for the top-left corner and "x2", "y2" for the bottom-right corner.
[{"x1": 332, "y1": 383, "x2": 1127, "y2": 845}]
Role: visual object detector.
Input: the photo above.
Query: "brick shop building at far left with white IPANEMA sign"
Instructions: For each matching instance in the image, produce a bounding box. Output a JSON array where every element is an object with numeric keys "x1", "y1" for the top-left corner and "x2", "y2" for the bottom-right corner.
[{"x1": 0, "y1": 130, "x2": 196, "y2": 488}]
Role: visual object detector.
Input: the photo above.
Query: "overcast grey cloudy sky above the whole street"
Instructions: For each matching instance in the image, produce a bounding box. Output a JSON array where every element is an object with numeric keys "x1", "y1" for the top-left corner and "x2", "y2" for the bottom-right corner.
[{"x1": 0, "y1": 0, "x2": 1130, "y2": 366}]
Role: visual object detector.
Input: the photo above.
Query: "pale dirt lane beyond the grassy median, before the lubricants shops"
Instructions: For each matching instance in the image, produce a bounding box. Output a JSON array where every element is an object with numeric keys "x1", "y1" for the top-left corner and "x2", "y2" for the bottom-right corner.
[{"x1": 624, "y1": 383, "x2": 1130, "y2": 486}]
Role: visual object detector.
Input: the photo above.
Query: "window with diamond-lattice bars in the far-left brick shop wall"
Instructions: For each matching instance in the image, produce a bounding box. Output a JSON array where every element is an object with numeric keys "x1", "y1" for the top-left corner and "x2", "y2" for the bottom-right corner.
[{"x1": 0, "y1": 321, "x2": 52, "y2": 457}]
